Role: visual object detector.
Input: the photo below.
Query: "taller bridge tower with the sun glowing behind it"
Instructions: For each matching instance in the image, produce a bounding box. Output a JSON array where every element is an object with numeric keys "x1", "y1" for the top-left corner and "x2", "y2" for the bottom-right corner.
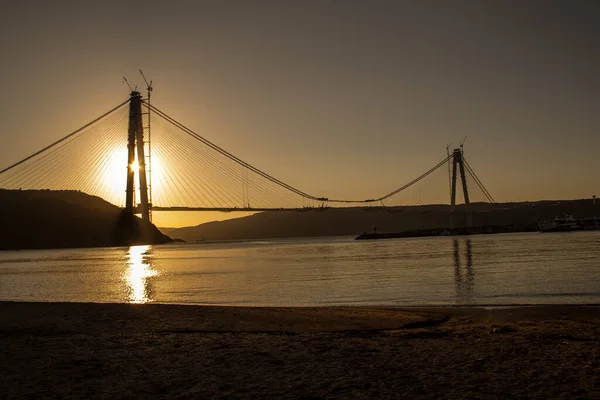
[{"x1": 125, "y1": 90, "x2": 150, "y2": 221}]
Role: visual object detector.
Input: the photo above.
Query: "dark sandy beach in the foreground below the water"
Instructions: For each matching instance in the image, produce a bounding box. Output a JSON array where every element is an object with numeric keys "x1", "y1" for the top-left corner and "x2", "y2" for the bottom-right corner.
[{"x1": 0, "y1": 302, "x2": 600, "y2": 399}]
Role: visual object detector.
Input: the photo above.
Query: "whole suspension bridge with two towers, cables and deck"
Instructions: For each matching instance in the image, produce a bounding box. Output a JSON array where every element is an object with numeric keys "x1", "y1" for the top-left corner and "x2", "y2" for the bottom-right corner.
[{"x1": 0, "y1": 86, "x2": 494, "y2": 221}]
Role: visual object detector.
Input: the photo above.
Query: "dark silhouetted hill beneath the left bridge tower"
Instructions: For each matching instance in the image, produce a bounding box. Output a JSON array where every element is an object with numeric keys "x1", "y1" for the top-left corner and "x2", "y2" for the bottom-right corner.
[{"x1": 0, "y1": 189, "x2": 171, "y2": 250}]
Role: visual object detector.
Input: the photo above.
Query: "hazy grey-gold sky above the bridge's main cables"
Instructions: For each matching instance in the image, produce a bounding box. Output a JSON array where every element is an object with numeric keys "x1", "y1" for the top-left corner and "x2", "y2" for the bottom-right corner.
[{"x1": 0, "y1": 0, "x2": 600, "y2": 225}]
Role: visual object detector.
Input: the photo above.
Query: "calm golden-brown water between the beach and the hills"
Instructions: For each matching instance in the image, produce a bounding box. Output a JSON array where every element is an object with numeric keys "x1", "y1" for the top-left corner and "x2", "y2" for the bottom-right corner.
[{"x1": 0, "y1": 231, "x2": 600, "y2": 306}]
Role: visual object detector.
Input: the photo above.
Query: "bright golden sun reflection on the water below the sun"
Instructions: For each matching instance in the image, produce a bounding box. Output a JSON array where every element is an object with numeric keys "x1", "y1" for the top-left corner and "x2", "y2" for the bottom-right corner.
[{"x1": 123, "y1": 245, "x2": 159, "y2": 304}]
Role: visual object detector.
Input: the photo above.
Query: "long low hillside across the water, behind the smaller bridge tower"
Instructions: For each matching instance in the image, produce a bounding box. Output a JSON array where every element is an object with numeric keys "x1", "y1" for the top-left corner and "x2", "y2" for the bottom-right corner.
[{"x1": 169, "y1": 200, "x2": 600, "y2": 241}]
